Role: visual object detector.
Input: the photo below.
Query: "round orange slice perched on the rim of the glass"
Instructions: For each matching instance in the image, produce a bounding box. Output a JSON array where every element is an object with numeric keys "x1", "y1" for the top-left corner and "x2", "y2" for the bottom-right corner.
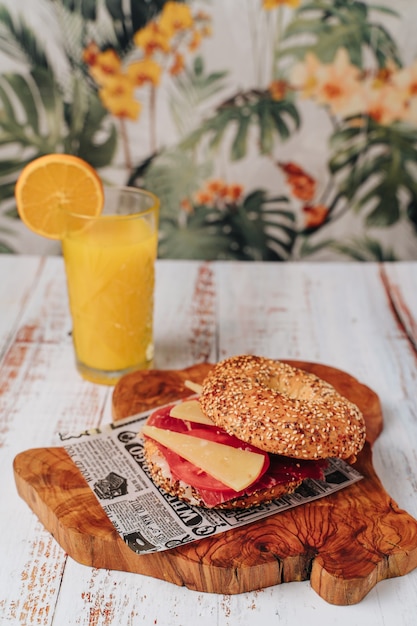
[{"x1": 15, "y1": 154, "x2": 104, "y2": 239}]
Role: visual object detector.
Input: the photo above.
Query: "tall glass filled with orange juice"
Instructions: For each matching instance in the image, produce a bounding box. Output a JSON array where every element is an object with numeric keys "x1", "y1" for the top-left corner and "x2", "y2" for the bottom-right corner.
[{"x1": 62, "y1": 187, "x2": 159, "y2": 385}]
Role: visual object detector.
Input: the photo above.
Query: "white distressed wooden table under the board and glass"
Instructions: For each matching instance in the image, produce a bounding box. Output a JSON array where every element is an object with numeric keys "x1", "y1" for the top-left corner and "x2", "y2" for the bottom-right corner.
[{"x1": 0, "y1": 255, "x2": 417, "y2": 626}]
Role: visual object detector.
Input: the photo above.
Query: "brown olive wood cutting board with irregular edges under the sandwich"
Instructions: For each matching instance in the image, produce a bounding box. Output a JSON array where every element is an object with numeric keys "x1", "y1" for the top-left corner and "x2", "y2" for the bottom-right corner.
[{"x1": 14, "y1": 361, "x2": 417, "y2": 605}]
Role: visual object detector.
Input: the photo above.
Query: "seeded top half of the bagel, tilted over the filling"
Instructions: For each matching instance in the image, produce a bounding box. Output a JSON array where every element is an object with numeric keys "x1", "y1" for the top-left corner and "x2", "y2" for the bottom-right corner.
[{"x1": 200, "y1": 355, "x2": 365, "y2": 462}]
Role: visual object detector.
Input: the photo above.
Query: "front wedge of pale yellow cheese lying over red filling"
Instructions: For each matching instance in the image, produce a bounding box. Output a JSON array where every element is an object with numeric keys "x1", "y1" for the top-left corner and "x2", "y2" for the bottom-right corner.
[{"x1": 142, "y1": 424, "x2": 264, "y2": 491}]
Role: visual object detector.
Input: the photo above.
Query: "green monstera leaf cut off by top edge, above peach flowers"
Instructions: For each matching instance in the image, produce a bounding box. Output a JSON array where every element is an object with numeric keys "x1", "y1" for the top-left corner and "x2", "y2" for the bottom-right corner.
[{"x1": 280, "y1": 0, "x2": 401, "y2": 67}]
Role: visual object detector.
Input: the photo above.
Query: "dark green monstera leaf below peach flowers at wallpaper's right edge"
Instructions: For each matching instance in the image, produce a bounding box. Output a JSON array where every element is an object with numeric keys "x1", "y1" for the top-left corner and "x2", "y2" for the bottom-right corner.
[{"x1": 329, "y1": 120, "x2": 417, "y2": 227}]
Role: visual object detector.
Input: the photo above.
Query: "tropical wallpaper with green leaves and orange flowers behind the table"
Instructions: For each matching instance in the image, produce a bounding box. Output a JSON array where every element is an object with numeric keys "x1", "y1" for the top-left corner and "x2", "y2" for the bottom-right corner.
[{"x1": 0, "y1": 0, "x2": 417, "y2": 261}]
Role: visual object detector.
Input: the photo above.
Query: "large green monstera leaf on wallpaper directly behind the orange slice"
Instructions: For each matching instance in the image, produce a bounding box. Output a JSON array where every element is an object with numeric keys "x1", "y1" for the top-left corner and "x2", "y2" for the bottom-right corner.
[{"x1": 0, "y1": 68, "x2": 117, "y2": 200}]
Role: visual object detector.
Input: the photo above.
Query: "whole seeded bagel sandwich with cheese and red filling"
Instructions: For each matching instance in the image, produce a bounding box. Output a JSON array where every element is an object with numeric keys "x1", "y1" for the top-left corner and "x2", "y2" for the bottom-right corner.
[{"x1": 140, "y1": 355, "x2": 366, "y2": 509}]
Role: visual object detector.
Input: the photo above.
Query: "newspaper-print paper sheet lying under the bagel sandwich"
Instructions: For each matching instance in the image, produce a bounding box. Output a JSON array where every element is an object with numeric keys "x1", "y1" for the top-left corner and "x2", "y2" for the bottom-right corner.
[{"x1": 60, "y1": 407, "x2": 362, "y2": 554}]
